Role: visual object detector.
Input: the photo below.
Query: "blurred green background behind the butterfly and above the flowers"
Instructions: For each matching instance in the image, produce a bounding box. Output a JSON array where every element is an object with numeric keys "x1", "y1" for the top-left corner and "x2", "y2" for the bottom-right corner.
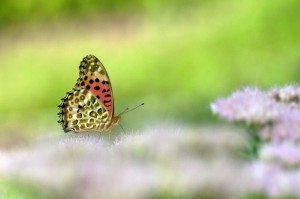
[{"x1": 0, "y1": 0, "x2": 300, "y2": 147}]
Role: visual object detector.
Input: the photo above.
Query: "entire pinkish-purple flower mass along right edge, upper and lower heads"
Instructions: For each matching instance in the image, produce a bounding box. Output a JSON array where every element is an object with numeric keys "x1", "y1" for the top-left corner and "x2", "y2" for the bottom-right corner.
[{"x1": 211, "y1": 84, "x2": 300, "y2": 198}]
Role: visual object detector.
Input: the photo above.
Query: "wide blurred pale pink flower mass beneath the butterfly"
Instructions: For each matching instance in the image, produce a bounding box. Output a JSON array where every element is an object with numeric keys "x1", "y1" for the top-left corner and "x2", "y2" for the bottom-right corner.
[{"x1": 0, "y1": 126, "x2": 251, "y2": 199}]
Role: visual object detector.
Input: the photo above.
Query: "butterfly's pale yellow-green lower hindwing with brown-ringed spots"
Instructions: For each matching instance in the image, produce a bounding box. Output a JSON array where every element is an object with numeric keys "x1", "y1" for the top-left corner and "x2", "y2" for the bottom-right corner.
[{"x1": 58, "y1": 88, "x2": 110, "y2": 132}]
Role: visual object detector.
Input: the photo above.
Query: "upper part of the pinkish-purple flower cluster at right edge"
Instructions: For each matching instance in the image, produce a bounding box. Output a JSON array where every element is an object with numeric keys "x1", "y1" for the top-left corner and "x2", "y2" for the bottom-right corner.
[{"x1": 211, "y1": 85, "x2": 300, "y2": 142}]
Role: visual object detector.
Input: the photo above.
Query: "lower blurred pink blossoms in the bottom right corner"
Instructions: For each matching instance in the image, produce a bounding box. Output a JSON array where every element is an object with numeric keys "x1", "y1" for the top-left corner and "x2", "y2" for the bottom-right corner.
[{"x1": 250, "y1": 143, "x2": 300, "y2": 198}]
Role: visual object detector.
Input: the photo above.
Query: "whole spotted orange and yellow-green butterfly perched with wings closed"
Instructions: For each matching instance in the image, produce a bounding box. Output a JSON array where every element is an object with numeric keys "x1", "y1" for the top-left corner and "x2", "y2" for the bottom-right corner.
[{"x1": 58, "y1": 55, "x2": 120, "y2": 133}]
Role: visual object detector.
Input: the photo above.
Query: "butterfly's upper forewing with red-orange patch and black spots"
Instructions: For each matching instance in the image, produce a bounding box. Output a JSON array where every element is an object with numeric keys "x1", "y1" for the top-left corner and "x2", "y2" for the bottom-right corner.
[{"x1": 75, "y1": 55, "x2": 114, "y2": 118}]
